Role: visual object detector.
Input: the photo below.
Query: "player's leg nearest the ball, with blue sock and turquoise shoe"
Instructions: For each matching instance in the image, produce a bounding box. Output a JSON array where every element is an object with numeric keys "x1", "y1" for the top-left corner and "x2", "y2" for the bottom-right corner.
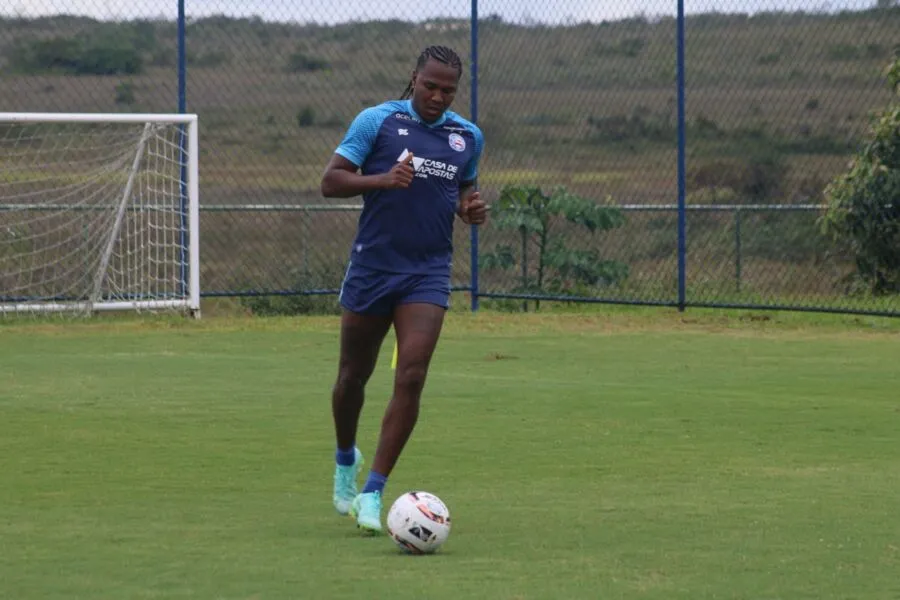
[{"x1": 351, "y1": 303, "x2": 446, "y2": 532}]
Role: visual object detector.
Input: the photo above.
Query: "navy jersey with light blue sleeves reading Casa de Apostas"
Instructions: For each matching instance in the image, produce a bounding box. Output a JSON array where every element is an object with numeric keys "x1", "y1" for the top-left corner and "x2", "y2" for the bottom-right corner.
[{"x1": 336, "y1": 100, "x2": 484, "y2": 274}]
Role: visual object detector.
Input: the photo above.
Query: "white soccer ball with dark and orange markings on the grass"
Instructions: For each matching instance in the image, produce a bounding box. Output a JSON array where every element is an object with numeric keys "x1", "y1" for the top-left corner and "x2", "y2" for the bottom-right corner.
[{"x1": 387, "y1": 492, "x2": 450, "y2": 554}]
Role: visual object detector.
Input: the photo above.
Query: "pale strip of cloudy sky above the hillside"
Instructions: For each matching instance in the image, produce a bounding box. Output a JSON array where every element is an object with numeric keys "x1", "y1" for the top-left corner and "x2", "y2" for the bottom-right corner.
[{"x1": 0, "y1": 0, "x2": 875, "y2": 24}]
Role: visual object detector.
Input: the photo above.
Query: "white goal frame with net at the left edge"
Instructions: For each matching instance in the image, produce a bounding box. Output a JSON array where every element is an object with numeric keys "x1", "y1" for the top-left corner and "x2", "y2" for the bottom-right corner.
[{"x1": 0, "y1": 113, "x2": 200, "y2": 316}]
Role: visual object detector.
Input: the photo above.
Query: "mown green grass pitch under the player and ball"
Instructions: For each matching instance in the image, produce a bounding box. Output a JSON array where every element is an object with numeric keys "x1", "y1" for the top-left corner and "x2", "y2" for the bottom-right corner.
[{"x1": 0, "y1": 308, "x2": 900, "y2": 600}]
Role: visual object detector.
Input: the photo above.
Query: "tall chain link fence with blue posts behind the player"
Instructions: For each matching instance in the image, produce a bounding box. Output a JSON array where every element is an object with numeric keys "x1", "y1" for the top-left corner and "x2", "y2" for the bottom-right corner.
[{"x1": 0, "y1": 0, "x2": 900, "y2": 315}]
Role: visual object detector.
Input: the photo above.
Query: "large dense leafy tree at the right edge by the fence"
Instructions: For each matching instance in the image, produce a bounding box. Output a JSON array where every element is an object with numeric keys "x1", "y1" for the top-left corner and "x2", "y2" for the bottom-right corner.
[{"x1": 821, "y1": 56, "x2": 900, "y2": 294}]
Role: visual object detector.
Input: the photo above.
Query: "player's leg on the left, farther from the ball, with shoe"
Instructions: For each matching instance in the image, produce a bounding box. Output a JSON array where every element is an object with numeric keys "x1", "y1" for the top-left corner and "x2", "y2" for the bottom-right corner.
[{"x1": 331, "y1": 309, "x2": 391, "y2": 514}]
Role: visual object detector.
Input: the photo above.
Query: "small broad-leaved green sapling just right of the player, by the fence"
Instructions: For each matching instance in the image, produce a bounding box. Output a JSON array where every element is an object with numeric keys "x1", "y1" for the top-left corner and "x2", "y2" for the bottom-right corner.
[{"x1": 480, "y1": 186, "x2": 628, "y2": 310}]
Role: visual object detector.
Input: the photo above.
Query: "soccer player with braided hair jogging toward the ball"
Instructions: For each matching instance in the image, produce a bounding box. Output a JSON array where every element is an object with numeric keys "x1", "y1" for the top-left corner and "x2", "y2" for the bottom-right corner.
[{"x1": 322, "y1": 46, "x2": 487, "y2": 533}]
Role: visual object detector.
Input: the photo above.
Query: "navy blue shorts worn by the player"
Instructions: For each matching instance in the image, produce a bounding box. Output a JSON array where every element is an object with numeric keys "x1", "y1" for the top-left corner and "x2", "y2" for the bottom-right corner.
[{"x1": 338, "y1": 262, "x2": 450, "y2": 315}]
